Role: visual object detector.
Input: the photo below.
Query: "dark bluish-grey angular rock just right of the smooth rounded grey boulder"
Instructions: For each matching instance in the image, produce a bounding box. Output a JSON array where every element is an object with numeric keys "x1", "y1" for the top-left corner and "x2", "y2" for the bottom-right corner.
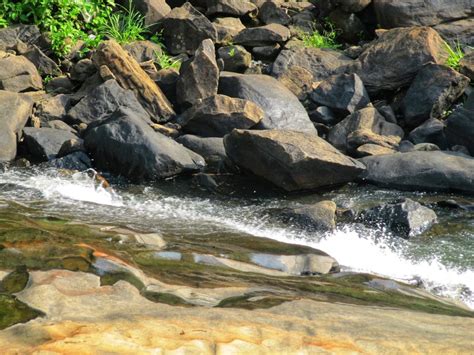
[{"x1": 310, "y1": 74, "x2": 370, "y2": 115}]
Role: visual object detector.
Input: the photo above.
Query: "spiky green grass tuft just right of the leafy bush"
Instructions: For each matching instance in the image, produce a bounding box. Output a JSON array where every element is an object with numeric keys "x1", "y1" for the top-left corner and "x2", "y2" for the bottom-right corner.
[{"x1": 102, "y1": 2, "x2": 148, "y2": 44}]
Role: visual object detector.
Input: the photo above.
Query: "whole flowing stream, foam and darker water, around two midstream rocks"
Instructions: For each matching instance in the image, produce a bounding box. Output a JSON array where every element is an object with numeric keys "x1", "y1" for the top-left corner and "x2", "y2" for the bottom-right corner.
[{"x1": 0, "y1": 169, "x2": 474, "y2": 308}]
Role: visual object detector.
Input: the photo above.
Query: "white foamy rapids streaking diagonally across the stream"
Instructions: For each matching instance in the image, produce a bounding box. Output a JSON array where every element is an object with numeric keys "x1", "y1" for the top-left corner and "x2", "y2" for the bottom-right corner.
[{"x1": 0, "y1": 172, "x2": 474, "y2": 308}]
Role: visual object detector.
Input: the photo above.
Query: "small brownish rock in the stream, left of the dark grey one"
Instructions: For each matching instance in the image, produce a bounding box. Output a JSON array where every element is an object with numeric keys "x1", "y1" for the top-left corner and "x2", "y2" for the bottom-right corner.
[{"x1": 282, "y1": 201, "x2": 336, "y2": 232}]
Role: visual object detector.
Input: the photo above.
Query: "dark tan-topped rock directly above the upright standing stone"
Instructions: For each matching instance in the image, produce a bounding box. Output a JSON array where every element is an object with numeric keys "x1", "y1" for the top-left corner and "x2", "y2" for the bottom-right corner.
[{"x1": 163, "y1": 2, "x2": 217, "y2": 55}]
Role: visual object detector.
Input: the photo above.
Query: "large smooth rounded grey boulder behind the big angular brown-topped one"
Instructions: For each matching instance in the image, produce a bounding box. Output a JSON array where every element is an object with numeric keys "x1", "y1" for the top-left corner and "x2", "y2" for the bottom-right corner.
[{"x1": 219, "y1": 72, "x2": 317, "y2": 135}]
